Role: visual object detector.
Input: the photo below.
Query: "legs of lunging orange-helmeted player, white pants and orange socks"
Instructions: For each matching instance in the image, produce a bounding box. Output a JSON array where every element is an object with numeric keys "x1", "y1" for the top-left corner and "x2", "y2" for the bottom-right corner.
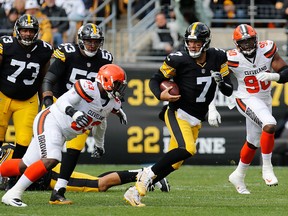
[{"x1": 1, "y1": 110, "x2": 65, "y2": 207}]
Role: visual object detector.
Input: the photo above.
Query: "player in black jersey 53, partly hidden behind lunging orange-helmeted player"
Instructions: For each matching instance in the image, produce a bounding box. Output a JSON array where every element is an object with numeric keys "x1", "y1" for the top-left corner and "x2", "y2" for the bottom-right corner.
[{"x1": 43, "y1": 23, "x2": 127, "y2": 204}]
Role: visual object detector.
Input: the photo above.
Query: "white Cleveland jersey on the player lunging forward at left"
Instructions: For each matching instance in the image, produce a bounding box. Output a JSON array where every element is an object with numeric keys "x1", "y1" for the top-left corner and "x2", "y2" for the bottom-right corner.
[{"x1": 50, "y1": 79, "x2": 121, "y2": 140}]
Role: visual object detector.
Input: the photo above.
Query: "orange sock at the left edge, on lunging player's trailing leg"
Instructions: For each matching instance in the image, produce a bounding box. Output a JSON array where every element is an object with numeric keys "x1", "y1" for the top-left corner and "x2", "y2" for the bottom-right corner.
[{"x1": 0, "y1": 159, "x2": 21, "y2": 177}]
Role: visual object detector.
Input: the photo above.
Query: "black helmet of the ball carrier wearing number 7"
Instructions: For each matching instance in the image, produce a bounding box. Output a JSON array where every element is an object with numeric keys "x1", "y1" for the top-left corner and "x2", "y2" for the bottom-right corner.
[{"x1": 184, "y1": 22, "x2": 211, "y2": 58}]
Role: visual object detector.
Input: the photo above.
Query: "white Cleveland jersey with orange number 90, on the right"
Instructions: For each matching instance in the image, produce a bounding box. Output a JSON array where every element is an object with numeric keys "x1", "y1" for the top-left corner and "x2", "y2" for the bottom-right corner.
[{"x1": 227, "y1": 40, "x2": 278, "y2": 98}]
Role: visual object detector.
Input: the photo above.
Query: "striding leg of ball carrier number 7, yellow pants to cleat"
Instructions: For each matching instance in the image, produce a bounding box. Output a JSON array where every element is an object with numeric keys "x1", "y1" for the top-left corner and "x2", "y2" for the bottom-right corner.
[{"x1": 136, "y1": 109, "x2": 197, "y2": 196}]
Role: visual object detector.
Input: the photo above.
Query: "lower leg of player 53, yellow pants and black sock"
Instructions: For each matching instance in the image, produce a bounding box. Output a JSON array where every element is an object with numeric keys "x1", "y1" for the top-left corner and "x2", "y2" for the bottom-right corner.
[{"x1": 49, "y1": 131, "x2": 89, "y2": 204}]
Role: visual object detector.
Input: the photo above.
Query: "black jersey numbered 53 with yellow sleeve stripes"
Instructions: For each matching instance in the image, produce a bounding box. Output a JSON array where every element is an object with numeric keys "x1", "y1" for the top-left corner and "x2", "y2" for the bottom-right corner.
[{"x1": 49, "y1": 43, "x2": 113, "y2": 98}]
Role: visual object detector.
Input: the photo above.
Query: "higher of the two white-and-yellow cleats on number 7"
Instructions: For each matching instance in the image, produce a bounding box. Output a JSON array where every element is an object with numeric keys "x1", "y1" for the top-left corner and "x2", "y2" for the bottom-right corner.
[{"x1": 135, "y1": 167, "x2": 156, "y2": 196}]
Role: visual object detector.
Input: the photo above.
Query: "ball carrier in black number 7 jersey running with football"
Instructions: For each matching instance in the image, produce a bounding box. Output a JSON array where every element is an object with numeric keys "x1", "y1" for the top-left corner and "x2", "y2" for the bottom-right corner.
[{"x1": 124, "y1": 22, "x2": 233, "y2": 206}]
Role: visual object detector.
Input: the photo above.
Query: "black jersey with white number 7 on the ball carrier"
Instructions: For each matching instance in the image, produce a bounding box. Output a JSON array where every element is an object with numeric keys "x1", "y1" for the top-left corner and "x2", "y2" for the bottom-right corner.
[{"x1": 150, "y1": 48, "x2": 229, "y2": 121}]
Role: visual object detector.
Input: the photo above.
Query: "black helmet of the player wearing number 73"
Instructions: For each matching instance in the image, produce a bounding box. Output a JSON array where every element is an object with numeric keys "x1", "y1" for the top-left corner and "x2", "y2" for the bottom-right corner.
[{"x1": 14, "y1": 14, "x2": 39, "y2": 46}]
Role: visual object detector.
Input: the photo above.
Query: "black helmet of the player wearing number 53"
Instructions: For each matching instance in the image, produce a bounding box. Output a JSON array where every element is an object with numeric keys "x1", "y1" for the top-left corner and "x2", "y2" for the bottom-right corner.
[{"x1": 78, "y1": 23, "x2": 104, "y2": 57}]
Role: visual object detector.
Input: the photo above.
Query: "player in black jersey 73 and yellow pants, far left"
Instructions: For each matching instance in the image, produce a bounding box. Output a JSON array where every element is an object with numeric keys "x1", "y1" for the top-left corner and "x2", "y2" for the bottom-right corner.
[{"x1": 0, "y1": 14, "x2": 53, "y2": 186}]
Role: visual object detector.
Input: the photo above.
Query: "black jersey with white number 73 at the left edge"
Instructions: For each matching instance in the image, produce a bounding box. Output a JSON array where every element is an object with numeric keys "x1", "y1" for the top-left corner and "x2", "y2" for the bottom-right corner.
[{"x1": 0, "y1": 36, "x2": 53, "y2": 100}]
